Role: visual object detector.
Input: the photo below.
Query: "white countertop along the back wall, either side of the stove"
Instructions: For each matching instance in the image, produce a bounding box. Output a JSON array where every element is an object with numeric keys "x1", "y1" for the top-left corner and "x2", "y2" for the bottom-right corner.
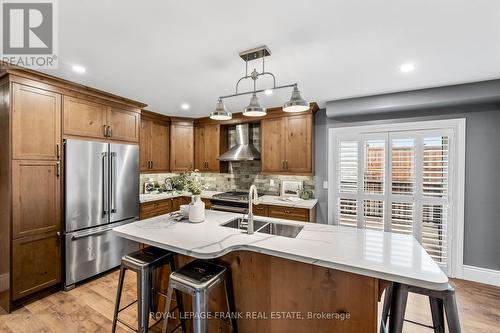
[{"x1": 139, "y1": 191, "x2": 318, "y2": 209}]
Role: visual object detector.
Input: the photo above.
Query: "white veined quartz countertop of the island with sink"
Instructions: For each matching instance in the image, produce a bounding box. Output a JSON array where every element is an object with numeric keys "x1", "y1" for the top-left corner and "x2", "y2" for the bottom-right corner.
[{"x1": 113, "y1": 210, "x2": 448, "y2": 290}]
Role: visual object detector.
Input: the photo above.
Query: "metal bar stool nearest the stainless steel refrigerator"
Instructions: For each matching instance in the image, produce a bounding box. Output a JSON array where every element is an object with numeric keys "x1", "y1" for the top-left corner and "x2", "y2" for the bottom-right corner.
[{"x1": 111, "y1": 247, "x2": 186, "y2": 333}]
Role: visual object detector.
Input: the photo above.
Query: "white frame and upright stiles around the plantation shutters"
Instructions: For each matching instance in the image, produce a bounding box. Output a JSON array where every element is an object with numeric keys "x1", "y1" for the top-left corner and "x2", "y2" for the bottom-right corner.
[{"x1": 328, "y1": 118, "x2": 466, "y2": 277}]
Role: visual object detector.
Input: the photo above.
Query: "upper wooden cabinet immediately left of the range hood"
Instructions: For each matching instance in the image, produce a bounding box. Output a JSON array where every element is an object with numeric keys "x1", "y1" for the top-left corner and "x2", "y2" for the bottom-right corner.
[{"x1": 194, "y1": 125, "x2": 228, "y2": 172}]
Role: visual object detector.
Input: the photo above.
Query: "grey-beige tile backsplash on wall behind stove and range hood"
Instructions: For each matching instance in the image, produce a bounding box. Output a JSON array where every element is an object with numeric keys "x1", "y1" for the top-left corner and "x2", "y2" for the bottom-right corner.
[{"x1": 141, "y1": 124, "x2": 315, "y2": 195}]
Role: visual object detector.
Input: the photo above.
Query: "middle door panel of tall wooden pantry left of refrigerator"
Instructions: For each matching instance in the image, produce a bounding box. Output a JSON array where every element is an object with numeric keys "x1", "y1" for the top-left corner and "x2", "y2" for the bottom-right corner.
[{"x1": 12, "y1": 160, "x2": 61, "y2": 239}]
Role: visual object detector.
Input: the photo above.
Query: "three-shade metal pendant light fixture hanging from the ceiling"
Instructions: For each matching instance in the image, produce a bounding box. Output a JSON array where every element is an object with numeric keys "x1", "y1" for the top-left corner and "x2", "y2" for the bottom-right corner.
[{"x1": 210, "y1": 45, "x2": 309, "y2": 120}]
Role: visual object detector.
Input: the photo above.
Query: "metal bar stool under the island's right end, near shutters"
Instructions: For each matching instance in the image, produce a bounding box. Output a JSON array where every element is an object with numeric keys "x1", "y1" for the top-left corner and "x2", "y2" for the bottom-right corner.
[{"x1": 380, "y1": 282, "x2": 461, "y2": 333}]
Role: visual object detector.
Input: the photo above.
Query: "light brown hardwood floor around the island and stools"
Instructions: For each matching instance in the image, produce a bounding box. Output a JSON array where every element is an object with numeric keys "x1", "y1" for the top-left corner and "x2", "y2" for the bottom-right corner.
[{"x1": 0, "y1": 271, "x2": 500, "y2": 333}]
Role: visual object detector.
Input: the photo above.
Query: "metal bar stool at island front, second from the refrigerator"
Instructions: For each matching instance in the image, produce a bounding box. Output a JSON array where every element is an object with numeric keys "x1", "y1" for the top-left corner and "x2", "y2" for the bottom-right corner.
[{"x1": 163, "y1": 260, "x2": 238, "y2": 333}]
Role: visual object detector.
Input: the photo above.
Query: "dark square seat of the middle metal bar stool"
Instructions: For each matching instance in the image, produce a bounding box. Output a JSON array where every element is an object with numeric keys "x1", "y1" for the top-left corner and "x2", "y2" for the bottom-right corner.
[{"x1": 170, "y1": 260, "x2": 226, "y2": 289}]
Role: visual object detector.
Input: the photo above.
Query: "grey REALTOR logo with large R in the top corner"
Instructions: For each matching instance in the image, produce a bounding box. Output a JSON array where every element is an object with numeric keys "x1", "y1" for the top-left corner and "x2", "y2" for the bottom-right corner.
[{"x1": 1, "y1": 0, "x2": 57, "y2": 69}]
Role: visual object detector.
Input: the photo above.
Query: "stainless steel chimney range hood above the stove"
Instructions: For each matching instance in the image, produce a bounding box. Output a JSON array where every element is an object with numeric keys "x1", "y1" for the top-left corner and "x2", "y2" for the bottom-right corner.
[{"x1": 219, "y1": 124, "x2": 260, "y2": 161}]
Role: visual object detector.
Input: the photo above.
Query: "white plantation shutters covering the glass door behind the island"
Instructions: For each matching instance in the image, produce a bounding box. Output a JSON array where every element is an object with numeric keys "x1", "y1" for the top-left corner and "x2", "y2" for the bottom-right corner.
[{"x1": 329, "y1": 127, "x2": 453, "y2": 268}]
